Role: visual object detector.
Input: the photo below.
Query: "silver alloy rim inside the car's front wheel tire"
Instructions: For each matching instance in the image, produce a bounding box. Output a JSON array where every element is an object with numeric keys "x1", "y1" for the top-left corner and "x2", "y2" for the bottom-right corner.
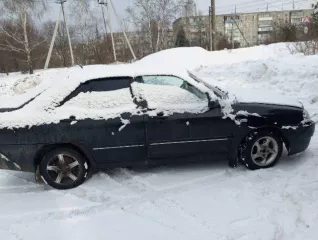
[{"x1": 251, "y1": 137, "x2": 278, "y2": 167}]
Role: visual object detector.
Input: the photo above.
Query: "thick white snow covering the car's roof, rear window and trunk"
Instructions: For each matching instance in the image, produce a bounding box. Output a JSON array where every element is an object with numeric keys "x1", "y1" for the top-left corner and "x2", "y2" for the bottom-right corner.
[{"x1": 0, "y1": 64, "x2": 216, "y2": 128}]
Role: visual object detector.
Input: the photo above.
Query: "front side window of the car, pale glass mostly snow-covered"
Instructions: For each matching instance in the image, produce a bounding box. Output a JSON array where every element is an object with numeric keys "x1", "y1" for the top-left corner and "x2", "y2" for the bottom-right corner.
[{"x1": 132, "y1": 76, "x2": 209, "y2": 112}]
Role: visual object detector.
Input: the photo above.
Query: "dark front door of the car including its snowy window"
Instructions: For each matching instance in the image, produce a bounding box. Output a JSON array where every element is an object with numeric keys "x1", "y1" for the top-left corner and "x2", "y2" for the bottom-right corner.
[{"x1": 132, "y1": 76, "x2": 234, "y2": 162}]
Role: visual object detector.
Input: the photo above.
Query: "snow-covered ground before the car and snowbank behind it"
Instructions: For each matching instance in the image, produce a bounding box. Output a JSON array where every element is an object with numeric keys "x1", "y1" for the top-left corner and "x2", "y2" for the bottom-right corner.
[{"x1": 0, "y1": 44, "x2": 318, "y2": 240}]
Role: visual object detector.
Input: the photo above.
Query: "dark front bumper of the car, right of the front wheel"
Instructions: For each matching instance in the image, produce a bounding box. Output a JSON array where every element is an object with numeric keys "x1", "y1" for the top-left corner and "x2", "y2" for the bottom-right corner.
[{"x1": 283, "y1": 121, "x2": 316, "y2": 156}]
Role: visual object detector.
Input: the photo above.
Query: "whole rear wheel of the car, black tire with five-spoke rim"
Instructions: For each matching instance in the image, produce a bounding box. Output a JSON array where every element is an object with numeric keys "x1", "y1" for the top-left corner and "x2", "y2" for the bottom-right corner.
[{"x1": 39, "y1": 148, "x2": 88, "y2": 190}]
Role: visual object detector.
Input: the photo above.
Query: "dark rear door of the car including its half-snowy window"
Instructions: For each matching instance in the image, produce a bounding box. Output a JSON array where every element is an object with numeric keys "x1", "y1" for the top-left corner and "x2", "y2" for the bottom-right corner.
[{"x1": 55, "y1": 78, "x2": 146, "y2": 168}]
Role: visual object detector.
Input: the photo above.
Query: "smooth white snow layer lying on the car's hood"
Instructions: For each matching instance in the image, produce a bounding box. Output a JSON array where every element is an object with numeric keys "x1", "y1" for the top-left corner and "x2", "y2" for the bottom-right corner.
[{"x1": 227, "y1": 88, "x2": 303, "y2": 108}]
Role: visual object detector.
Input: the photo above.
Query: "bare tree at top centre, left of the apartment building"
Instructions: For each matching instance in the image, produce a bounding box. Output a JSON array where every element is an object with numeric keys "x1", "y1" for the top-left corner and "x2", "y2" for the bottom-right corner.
[{"x1": 126, "y1": 0, "x2": 184, "y2": 53}]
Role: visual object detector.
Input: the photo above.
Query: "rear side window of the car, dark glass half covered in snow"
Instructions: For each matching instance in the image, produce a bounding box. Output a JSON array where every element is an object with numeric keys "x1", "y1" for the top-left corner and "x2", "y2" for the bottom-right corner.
[{"x1": 63, "y1": 78, "x2": 135, "y2": 110}]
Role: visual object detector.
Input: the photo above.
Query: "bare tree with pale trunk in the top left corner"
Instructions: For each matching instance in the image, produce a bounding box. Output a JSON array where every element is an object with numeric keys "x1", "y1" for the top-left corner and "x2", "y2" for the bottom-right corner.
[{"x1": 0, "y1": 0, "x2": 45, "y2": 74}]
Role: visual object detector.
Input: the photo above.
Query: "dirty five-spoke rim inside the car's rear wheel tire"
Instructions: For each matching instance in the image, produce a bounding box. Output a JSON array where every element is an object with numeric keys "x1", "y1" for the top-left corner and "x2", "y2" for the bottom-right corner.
[{"x1": 46, "y1": 154, "x2": 81, "y2": 185}]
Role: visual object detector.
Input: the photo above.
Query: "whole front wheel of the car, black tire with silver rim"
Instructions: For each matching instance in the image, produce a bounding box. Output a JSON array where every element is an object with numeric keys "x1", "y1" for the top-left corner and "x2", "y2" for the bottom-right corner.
[{"x1": 239, "y1": 130, "x2": 283, "y2": 170}]
